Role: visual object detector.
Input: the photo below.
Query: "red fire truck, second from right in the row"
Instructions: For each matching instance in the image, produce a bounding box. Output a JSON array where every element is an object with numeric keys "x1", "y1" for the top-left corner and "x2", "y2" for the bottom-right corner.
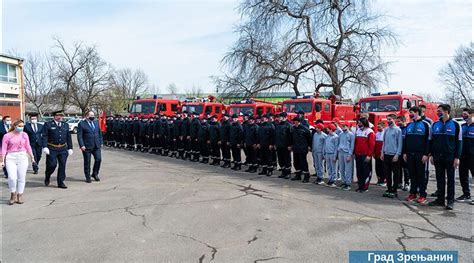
[{"x1": 282, "y1": 95, "x2": 357, "y2": 127}]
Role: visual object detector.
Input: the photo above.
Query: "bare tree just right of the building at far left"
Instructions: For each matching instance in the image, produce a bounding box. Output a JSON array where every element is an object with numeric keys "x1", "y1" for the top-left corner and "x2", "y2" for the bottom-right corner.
[{"x1": 23, "y1": 53, "x2": 57, "y2": 116}]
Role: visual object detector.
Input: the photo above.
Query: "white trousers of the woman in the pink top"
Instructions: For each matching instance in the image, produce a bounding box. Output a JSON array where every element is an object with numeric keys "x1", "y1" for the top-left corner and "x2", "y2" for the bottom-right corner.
[{"x1": 5, "y1": 152, "x2": 28, "y2": 194}]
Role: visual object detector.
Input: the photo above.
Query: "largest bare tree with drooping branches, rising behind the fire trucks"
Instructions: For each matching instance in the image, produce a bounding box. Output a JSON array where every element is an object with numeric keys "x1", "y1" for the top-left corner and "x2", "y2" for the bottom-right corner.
[{"x1": 219, "y1": 0, "x2": 396, "y2": 95}]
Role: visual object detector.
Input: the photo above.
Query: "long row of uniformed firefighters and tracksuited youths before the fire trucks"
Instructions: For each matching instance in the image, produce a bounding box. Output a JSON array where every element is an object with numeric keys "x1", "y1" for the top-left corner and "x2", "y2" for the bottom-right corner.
[{"x1": 104, "y1": 105, "x2": 474, "y2": 209}]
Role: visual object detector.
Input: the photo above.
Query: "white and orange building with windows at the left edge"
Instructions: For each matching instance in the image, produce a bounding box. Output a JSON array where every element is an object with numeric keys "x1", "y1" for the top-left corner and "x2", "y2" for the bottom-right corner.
[{"x1": 0, "y1": 54, "x2": 25, "y2": 120}]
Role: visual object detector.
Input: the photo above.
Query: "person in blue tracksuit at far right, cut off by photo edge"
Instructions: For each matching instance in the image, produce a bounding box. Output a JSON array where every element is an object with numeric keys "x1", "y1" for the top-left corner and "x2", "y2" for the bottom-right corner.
[{"x1": 456, "y1": 108, "x2": 474, "y2": 204}]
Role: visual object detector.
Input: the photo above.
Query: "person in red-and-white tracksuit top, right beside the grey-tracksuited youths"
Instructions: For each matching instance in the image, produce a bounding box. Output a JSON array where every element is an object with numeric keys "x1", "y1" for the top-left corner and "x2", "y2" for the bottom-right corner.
[{"x1": 354, "y1": 118, "x2": 375, "y2": 193}]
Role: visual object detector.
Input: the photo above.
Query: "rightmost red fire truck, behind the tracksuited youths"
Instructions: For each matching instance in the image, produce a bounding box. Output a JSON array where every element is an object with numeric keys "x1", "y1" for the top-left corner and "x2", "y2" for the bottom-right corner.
[{"x1": 354, "y1": 91, "x2": 438, "y2": 127}]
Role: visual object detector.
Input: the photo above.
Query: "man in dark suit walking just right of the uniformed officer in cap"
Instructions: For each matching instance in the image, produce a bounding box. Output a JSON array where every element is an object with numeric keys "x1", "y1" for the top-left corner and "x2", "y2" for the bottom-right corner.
[{"x1": 77, "y1": 111, "x2": 102, "y2": 183}]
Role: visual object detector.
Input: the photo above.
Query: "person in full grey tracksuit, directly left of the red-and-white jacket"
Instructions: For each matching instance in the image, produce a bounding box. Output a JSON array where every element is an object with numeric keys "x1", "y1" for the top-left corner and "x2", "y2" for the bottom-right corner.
[{"x1": 337, "y1": 123, "x2": 355, "y2": 191}]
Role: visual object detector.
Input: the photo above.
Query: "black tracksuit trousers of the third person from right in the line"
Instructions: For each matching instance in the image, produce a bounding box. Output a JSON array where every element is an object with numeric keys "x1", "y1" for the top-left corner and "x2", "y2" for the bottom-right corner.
[{"x1": 407, "y1": 153, "x2": 428, "y2": 197}]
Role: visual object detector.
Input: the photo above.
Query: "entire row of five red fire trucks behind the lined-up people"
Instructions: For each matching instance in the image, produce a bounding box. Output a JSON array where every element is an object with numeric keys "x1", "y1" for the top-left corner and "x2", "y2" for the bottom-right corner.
[{"x1": 130, "y1": 92, "x2": 437, "y2": 129}]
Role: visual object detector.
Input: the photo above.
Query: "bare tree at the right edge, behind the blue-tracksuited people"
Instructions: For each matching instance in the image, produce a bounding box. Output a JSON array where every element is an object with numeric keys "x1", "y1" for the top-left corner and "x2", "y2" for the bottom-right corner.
[{"x1": 439, "y1": 42, "x2": 474, "y2": 110}]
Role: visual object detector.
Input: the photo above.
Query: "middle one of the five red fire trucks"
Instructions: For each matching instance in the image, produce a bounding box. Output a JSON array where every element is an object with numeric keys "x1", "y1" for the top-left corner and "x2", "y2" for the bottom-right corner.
[{"x1": 228, "y1": 99, "x2": 280, "y2": 120}]
